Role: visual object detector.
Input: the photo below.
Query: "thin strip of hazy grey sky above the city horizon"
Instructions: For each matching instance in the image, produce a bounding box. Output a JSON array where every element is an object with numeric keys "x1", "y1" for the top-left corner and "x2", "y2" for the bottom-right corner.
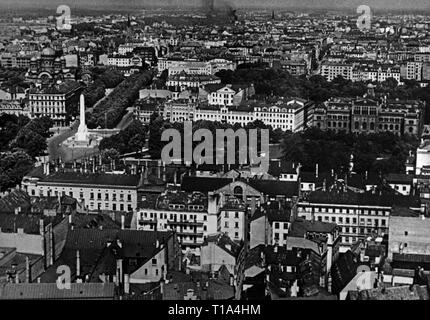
[{"x1": 0, "y1": 0, "x2": 430, "y2": 9}]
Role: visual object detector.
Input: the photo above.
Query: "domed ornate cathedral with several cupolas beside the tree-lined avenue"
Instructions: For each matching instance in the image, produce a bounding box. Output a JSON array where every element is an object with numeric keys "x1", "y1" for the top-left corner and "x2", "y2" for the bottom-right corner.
[{"x1": 26, "y1": 48, "x2": 75, "y2": 85}]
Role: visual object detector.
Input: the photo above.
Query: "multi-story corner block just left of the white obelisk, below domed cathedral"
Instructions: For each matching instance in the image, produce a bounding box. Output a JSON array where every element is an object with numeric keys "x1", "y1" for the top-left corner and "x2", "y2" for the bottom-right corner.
[{"x1": 29, "y1": 81, "x2": 82, "y2": 127}]
